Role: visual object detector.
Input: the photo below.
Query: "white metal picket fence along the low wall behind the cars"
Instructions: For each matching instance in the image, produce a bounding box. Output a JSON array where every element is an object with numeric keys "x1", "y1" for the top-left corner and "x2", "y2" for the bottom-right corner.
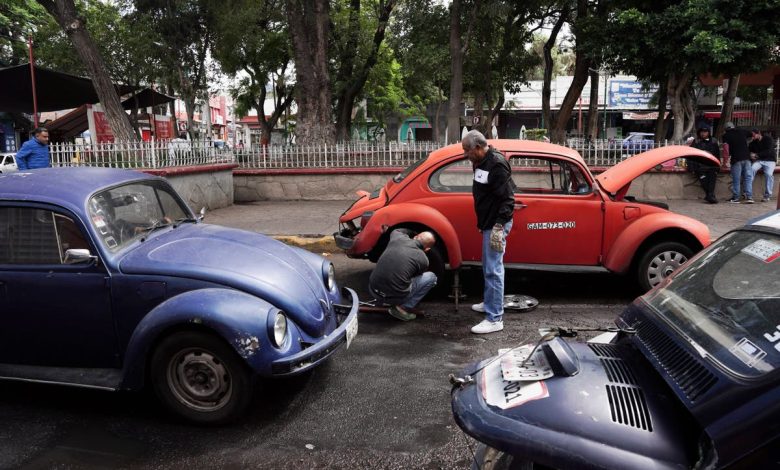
[{"x1": 50, "y1": 139, "x2": 780, "y2": 170}]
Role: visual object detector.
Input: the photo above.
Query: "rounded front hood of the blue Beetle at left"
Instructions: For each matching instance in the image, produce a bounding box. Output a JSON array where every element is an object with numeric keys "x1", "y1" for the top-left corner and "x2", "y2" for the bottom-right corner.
[{"x1": 119, "y1": 224, "x2": 329, "y2": 337}]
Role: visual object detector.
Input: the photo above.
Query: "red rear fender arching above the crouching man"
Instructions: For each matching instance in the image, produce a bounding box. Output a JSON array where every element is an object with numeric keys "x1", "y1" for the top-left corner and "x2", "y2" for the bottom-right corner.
[{"x1": 361, "y1": 202, "x2": 463, "y2": 269}]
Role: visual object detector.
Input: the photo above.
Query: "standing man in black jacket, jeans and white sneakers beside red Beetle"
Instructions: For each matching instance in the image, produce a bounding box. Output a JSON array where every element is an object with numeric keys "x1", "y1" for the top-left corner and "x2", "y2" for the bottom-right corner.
[{"x1": 461, "y1": 131, "x2": 515, "y2": 334}]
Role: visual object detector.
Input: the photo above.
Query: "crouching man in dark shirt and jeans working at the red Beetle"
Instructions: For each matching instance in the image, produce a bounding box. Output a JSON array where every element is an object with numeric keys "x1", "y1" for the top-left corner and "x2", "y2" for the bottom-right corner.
[{"x1": 368, "y1": 226, "x2": 436, "y2": 321}]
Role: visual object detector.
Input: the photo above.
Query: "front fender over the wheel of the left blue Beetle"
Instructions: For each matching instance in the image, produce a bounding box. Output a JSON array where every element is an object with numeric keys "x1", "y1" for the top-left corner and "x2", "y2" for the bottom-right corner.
[{"x1": 121, "y1": 288, "x2": 275, "y2": 389}]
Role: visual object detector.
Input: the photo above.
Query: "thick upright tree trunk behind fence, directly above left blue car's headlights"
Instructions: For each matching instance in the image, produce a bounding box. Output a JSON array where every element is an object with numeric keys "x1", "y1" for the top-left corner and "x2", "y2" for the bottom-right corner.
[{"x1": 286, "y1": 0, "x2": 336, "y2": 145}]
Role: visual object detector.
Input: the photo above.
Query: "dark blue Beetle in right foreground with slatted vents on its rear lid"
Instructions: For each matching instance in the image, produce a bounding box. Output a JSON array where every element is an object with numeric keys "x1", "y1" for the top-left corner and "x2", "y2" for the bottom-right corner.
[{"x1": 452, "y1": 211, "x2": 780, "y2": 469}]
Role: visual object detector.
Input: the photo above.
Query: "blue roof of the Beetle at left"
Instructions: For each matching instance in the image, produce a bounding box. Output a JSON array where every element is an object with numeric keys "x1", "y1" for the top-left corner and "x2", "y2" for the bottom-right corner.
[{"x1": 0, "y1": 167, "x2": 159, "y2": 208}]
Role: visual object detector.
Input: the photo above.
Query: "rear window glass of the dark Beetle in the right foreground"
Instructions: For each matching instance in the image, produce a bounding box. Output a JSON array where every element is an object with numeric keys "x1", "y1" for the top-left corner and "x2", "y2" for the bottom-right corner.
[{"x1": 644, "y1": 231, "x2": 780, "y2": 377}]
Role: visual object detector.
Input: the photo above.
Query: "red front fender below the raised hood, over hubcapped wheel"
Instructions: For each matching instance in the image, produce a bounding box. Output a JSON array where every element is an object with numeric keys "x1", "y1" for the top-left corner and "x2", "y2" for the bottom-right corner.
[{"x1": 604, "y1": 212, "x2": 710, "y2": 273}]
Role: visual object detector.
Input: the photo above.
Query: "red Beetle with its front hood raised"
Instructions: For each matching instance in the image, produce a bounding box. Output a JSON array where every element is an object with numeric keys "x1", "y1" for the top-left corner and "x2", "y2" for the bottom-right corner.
[{"x1": 334, "y1": 140, "x2": 720, "y2": 291}]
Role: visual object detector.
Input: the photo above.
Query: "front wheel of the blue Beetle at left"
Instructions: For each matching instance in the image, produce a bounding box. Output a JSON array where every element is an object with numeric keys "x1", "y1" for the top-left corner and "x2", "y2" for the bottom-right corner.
[{"x1": 151, "y1": 331, "x2": 252, "y2": 424}]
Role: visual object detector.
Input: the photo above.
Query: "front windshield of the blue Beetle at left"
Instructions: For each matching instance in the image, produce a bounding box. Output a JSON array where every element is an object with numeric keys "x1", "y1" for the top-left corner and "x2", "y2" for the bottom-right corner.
[{"x1": 88, "y1": 181, "x2": 192, "y2": 251}]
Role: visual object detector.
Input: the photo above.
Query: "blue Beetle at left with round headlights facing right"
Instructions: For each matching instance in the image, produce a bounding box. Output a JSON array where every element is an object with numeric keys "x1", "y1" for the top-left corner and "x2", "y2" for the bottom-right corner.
[{"x1": 0, "y1": 168, "x2": 359, "y2": 423}]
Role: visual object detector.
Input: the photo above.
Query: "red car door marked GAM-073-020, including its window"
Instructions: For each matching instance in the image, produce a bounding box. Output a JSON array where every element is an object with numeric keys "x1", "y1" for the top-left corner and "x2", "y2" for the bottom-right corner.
[{"x1": 504, "y1": 155, "x2": 604, "y2": 266}]
